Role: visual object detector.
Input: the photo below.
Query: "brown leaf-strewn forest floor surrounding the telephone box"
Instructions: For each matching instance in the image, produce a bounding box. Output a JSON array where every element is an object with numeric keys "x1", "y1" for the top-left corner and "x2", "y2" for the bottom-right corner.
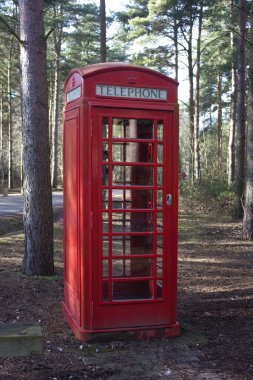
[{"x1": 0, "y1": 203, "x2": 253, "y2": 380}]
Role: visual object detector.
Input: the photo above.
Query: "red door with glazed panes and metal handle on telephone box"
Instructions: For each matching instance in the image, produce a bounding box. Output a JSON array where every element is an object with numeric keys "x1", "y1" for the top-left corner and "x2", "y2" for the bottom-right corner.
[{"x1": 92, "y1": 107, "x2": 177, "y2": 329}]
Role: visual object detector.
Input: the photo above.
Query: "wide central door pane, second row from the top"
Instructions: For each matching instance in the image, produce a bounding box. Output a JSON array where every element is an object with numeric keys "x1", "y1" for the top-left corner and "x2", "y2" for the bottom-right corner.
[{"x1": 112, "y1": 142, "x2": 154, "y2": 163}]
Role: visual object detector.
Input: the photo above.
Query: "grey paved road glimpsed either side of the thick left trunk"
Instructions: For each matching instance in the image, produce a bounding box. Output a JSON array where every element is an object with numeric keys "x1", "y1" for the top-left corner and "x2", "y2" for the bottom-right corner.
[{"x1": 0, "y1": 191, "x2": 63, "y2": 216}]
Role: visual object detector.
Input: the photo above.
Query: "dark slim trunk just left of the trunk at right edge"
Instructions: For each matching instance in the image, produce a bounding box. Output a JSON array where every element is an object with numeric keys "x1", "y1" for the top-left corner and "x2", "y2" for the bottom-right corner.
[{"x1": 234, "y1": 0, "x2": 245, "y2": 219}]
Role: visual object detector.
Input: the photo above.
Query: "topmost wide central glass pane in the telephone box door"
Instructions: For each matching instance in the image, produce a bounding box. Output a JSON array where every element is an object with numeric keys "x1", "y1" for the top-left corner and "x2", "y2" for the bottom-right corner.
[{"x1": 112, "y1": 118, "x2": 154, "y2": 139}]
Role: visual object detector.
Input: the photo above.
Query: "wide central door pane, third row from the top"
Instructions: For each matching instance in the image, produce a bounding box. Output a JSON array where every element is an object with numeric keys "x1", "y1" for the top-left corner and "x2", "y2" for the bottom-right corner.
[{"x1": 112, "y1": 165, "x2": 154, "y2": 186}]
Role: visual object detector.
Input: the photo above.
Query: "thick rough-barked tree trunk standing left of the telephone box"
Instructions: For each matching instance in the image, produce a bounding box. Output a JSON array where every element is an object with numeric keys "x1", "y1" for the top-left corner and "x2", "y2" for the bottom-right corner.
[{"x1": 19, "y1": 0, "x2": 54, "y2": 275}]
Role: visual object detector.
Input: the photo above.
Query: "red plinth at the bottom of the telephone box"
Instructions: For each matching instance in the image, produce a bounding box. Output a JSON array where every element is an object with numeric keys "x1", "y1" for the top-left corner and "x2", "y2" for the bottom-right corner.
[{"x1": 62, "y1": 302, "x2": 180, "y2": 342}]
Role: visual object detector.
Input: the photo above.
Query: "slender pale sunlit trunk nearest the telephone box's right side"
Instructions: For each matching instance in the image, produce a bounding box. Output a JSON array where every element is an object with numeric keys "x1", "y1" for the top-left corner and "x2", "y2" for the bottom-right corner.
[{"x1": 194, "y1": 3, "x2": 203, "y2": 182}]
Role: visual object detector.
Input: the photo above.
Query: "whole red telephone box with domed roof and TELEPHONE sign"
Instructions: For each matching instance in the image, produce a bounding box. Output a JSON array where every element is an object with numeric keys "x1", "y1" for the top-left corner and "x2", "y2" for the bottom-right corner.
[{"x1": 63, "y1": 63, "x2": 179, "y2": 341}]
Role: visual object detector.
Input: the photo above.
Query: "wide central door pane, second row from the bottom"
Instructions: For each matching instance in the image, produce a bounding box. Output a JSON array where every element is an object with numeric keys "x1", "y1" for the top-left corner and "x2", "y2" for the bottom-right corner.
[{"x1": 112, "y1": 258, "x2": 153, "y2": 277}]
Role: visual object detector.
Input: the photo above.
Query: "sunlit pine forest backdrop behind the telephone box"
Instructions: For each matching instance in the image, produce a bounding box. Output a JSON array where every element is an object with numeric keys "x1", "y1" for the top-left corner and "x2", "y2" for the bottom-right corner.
[{"x1": 0, "y1": 0, "x2": 253, "y2": 268}]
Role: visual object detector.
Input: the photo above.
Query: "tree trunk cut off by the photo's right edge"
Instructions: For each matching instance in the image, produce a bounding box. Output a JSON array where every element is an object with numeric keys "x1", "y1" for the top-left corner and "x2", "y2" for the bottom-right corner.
[{"x1": 243, "y1": 1, "x2": 253, "y2": 240}]
